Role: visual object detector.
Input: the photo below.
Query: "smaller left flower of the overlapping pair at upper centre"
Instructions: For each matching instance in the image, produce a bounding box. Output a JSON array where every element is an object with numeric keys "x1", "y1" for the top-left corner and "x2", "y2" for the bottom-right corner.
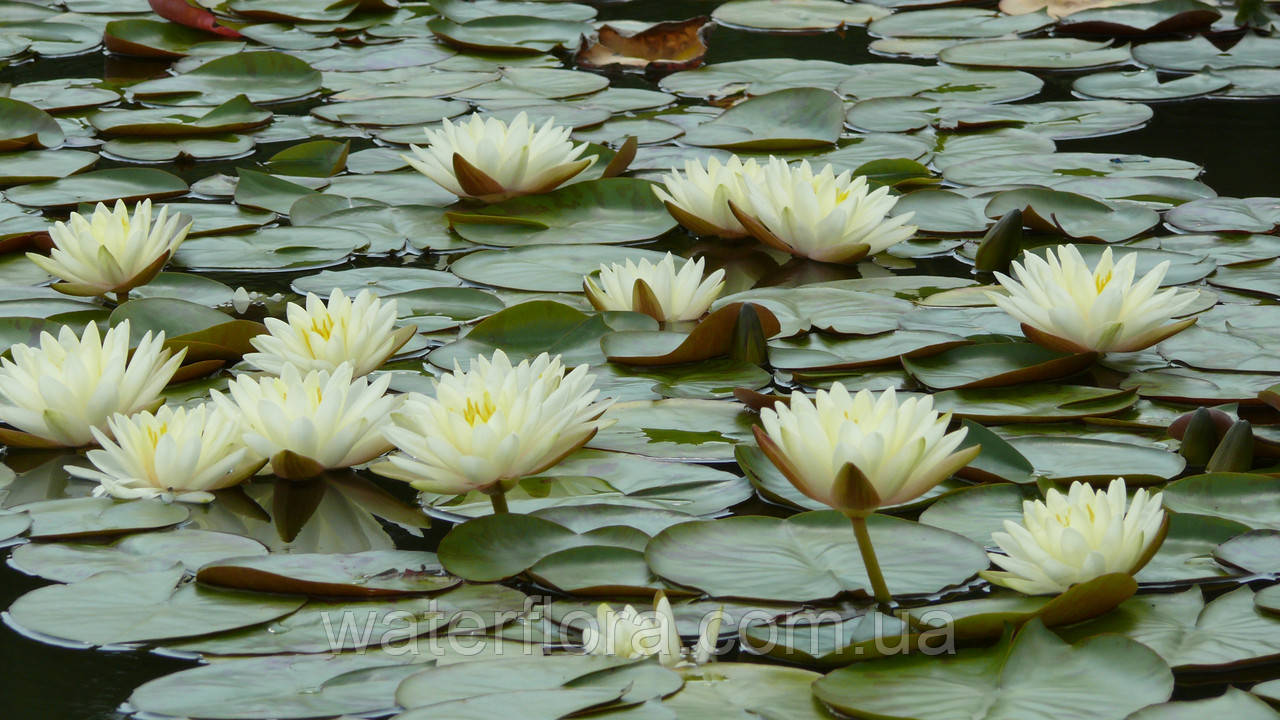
[{"x1": 653, "y1": 155, "x2": 764, "y2": 237}]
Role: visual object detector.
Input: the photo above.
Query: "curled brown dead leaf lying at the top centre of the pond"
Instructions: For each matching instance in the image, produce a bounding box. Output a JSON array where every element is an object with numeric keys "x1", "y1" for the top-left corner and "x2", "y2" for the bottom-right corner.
[{"x1": 575, "y1": 17, "x2": 710, "y2": 74}]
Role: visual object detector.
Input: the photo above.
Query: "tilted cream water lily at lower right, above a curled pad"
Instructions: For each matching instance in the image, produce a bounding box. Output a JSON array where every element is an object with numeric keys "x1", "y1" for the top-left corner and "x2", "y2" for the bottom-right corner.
[{"x1": 980, "y1": 478, "x2": 1167, "y2": 594}]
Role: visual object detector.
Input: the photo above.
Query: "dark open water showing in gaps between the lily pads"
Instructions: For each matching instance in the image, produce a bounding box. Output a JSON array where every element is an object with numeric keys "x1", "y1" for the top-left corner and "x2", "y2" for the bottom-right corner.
[{"x1": 0, "y1": 0, "x2": 1280, "y2": 720}]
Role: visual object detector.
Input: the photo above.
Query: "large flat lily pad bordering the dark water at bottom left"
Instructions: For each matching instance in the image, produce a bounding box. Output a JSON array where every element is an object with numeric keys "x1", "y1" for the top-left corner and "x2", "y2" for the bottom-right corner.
[{"x1": 9, "y1": 568, "x2": 303, "y2": 646}]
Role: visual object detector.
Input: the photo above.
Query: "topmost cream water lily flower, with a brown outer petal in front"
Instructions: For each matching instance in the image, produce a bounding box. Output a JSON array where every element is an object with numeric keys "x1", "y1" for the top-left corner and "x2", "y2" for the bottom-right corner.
[{"x1": 401, "y1": 113, "x2": 595, "y2": 202}]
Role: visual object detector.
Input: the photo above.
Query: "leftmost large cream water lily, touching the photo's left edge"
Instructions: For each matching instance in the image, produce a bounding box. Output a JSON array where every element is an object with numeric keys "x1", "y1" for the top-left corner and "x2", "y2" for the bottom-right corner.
[{"x1": 0, "y1": 320, "x2": 187, "y2": 447}]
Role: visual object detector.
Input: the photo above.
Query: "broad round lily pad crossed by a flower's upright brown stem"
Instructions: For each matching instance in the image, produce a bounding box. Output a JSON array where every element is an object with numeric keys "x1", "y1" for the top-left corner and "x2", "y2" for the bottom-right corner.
[{"x1": 645, "y1": 510, "x2": 988, "y2": 602}]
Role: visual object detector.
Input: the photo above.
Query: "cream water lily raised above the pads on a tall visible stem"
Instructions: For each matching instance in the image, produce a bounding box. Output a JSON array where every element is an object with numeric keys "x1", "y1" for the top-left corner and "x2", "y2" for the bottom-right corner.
[{"x1": 755, "y1": 382, "x2": 980, "y2": 515}]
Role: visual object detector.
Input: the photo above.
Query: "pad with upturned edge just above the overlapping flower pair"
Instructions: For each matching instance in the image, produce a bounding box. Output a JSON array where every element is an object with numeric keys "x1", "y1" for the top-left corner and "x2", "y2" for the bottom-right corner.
[{"x1": 682, "y1": 87, "x2": 845, "y2": 151}]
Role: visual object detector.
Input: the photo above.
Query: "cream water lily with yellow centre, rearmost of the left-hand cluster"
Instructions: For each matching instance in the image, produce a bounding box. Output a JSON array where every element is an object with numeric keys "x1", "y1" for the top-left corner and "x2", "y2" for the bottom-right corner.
[{"x1": 244, "y1": 288, "x2": 416, "y2": 377}]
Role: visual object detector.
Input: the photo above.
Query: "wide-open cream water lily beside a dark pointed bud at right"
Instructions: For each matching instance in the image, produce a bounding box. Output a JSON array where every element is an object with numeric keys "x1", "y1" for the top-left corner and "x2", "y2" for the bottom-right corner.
[{"x1": 987, "y1": 245, "x2": 1197, "y2": 352}]
